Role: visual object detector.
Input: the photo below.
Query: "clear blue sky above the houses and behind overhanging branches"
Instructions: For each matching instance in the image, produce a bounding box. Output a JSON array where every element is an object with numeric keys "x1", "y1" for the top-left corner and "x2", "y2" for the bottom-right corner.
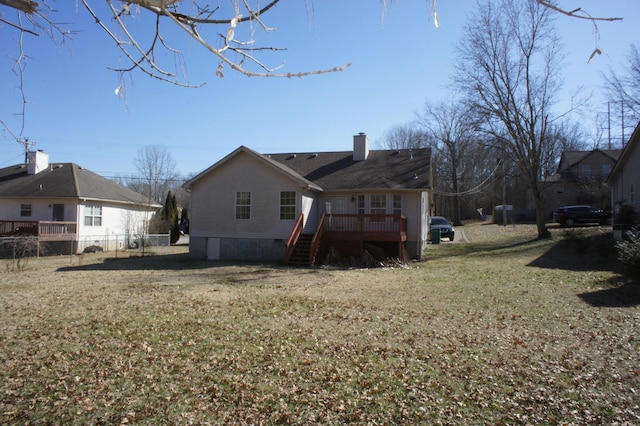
[{"x1": 0, "y1": 0, "x2": 640, "y2": 177}]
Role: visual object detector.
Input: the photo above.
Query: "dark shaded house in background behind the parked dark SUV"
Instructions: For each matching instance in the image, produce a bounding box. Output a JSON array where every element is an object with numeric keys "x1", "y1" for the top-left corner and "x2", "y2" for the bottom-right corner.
[{"x1": 542, "y1": 149, "x2": 622, "y2": 217}]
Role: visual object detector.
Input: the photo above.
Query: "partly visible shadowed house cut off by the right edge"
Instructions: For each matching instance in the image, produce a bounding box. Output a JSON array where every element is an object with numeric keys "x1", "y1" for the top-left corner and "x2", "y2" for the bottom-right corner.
[{"x1": 607, "y1": 123, "x2": 640, "y2": 228}]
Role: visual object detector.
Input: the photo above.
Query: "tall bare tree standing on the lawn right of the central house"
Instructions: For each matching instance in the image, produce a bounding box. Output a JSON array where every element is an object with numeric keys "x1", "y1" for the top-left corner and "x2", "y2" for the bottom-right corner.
[{"x1": 455, "y1": 0, "x2": 561, "y2": 238}]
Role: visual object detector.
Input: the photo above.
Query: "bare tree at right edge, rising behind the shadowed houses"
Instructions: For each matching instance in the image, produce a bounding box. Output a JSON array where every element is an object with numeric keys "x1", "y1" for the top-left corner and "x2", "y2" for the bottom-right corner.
[{"x1": 605, "y1": 44, "x2": 640, "y2": 144}]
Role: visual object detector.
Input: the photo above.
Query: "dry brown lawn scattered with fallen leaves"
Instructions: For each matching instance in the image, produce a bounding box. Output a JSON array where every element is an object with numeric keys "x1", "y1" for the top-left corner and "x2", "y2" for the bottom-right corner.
[{"x1": 0, "y1": 224, "x2": 640, "y2": 425}]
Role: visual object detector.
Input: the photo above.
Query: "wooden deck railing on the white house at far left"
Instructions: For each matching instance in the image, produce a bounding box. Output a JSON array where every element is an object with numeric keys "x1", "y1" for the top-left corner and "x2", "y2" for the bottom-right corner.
[{"x1": 0, "y1": 220, "x2": 77, "y2": 241}]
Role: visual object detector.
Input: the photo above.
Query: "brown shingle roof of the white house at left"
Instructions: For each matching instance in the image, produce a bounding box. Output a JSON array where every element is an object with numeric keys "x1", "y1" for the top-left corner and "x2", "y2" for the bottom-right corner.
[{"x1": 0, "y1": 163, "x2": 159, "y2": 207}]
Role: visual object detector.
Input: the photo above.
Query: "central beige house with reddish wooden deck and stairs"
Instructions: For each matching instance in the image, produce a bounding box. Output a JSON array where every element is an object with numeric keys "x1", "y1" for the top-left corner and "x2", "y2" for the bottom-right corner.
[{"x1": 183, "y1": 133, "x2": 431, "y2": 264}]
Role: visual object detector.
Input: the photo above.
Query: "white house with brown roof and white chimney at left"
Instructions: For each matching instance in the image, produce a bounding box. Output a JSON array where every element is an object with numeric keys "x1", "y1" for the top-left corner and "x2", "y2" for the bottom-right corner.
[{"x1": 0, "y1": 151, "x2": 161, "y2": 251}]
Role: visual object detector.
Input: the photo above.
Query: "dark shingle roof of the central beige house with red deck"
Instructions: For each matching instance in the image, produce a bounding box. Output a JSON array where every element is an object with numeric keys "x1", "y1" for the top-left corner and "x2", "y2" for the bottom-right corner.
[{"x1": 183, "y1": 146, "x2": 431, "y2": 191}]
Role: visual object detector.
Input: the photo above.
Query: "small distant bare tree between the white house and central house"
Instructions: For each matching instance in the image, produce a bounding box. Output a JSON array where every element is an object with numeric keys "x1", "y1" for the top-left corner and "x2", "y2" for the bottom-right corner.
[{"x1": 129, "y1": 145, "x2": 179, "y2": 203}]
